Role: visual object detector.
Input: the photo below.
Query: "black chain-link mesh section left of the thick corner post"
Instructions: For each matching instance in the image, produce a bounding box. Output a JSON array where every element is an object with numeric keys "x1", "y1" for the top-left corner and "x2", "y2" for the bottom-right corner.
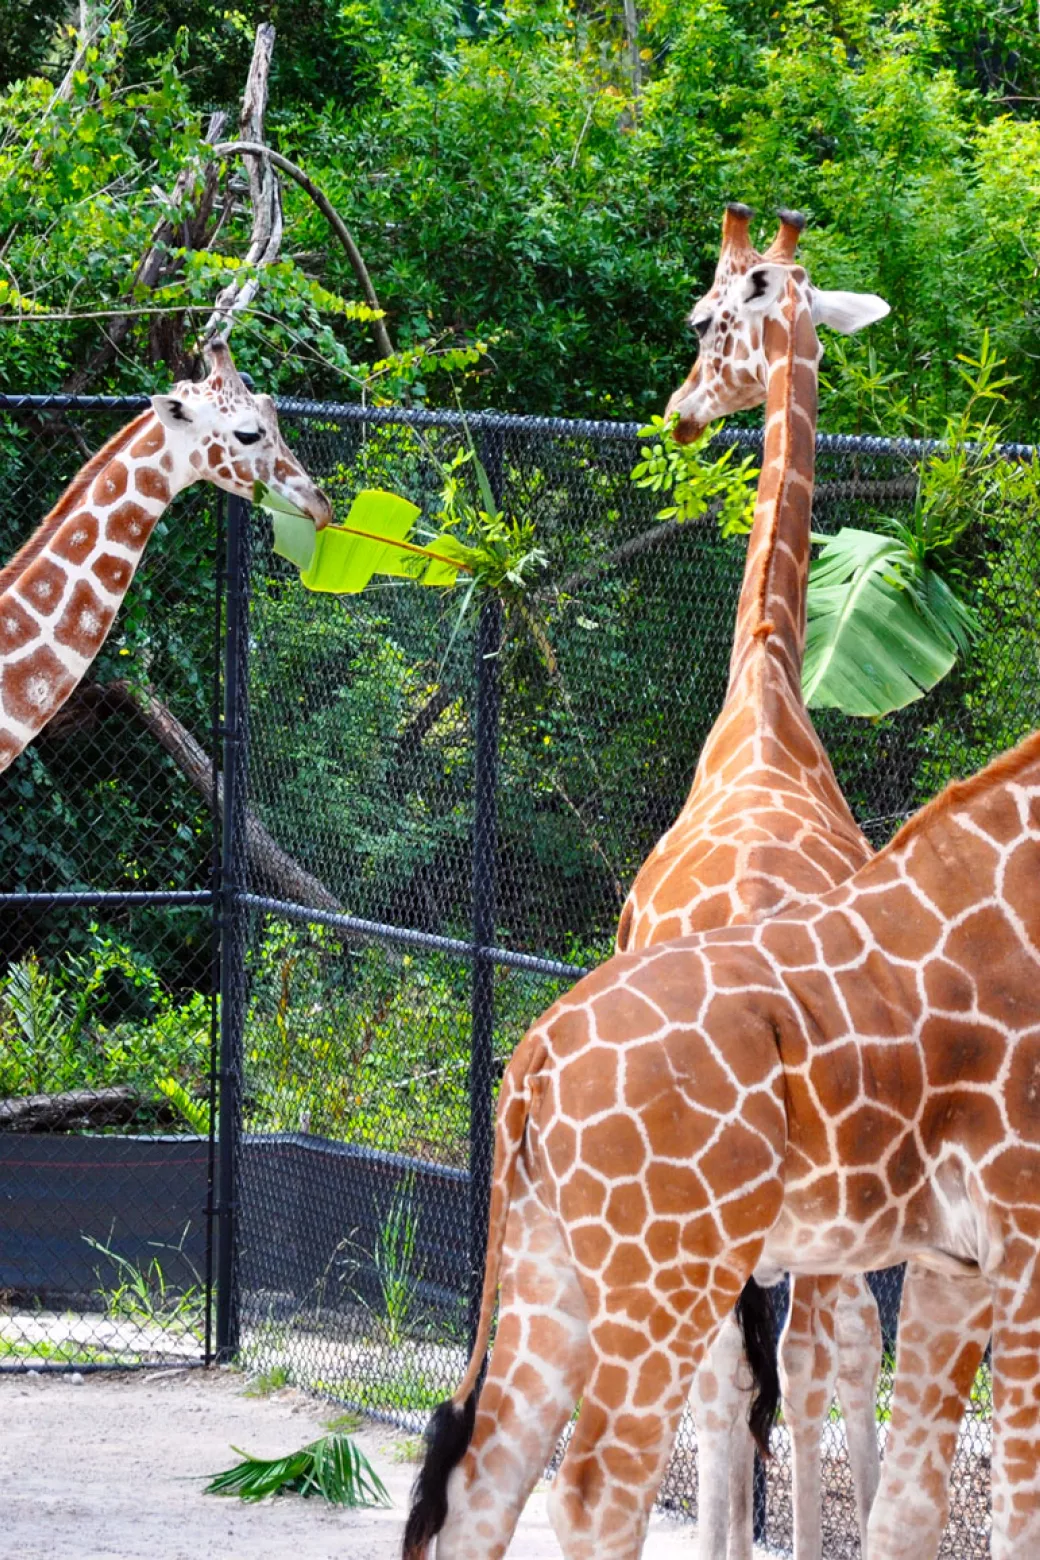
[{"x1": 0, "y1": 402, "x2": 220, "y2": 1370}]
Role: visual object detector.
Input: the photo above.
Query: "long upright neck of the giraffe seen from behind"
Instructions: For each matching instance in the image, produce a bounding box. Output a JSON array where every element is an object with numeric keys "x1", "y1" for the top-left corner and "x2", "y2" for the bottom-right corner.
[{"x1": 730, "y1": 281, "x2": 820, "y2": 699}]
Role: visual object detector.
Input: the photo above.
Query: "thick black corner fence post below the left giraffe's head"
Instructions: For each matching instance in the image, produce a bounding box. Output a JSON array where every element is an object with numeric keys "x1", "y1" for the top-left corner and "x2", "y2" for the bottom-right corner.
[{"x1": 217, "y1": 498, "x2": 249, "y2": 1362}]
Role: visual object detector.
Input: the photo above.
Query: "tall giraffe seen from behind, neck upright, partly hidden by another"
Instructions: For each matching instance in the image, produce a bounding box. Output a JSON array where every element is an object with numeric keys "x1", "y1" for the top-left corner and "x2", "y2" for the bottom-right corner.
[{"x1": 617, "y1": 204, "x2": 889, "y2": 1560}]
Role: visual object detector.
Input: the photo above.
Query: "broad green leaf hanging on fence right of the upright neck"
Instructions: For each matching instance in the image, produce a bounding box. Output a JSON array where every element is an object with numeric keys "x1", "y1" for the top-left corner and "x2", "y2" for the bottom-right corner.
[{"x1": 801, "y1": 527, "x2": 967, "y2": 716}]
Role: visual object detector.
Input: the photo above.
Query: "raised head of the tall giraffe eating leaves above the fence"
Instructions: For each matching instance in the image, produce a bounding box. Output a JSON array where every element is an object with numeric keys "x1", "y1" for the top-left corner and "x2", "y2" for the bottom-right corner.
[{"x1": 667, "y1": 204, "x2": 889, "y2": 445}]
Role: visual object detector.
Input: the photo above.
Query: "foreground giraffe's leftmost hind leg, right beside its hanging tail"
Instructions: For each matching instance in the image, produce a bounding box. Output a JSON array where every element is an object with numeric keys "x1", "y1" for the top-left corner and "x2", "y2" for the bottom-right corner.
[{"x1": 437, "y1": 1154, "x2": 589, "y2": 1560}]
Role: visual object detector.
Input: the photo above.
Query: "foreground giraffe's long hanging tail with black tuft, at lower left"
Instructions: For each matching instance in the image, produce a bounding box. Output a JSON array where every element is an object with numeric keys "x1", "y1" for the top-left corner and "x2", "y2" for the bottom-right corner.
[{"x1": 402, "y1": 1034, "x2": 546, "y2": 1560}]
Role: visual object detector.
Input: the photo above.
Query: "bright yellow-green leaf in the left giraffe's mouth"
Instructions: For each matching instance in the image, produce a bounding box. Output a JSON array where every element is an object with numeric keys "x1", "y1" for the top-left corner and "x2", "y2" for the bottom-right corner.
[{"x1": 253, "y1": 482, "x2": 477, "y2": 594}]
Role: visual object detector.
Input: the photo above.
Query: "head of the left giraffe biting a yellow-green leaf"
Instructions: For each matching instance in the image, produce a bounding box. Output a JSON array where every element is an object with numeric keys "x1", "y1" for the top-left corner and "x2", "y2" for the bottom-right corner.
[{"x1": 151, "y1": 339, "x2": 332, "y2": 530}]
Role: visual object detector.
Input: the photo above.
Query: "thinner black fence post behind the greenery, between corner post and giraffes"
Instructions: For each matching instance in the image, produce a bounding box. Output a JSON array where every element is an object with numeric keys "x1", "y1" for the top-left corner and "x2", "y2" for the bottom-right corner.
[{"x1": 468, "y1": 434, "x2": 502, "y2": 1348}]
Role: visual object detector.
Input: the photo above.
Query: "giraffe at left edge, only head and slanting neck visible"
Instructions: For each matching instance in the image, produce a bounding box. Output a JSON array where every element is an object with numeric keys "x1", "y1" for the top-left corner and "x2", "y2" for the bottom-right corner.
[{"x1": 0, "y1": 340, "x2": 332, "y2": 771}]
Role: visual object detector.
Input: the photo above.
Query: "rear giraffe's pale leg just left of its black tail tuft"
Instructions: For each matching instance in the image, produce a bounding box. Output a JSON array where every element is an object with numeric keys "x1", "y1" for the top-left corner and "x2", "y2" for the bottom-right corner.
[{"x1": 691, "y1": 1312, "x2": 755, "y2": 1560}]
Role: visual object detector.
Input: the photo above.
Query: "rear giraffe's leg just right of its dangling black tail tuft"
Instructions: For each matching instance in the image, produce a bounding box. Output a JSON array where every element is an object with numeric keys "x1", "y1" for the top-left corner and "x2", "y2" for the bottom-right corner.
[{"x1": 780, "y1": 1276, "x2": 837, "y2": 1560}]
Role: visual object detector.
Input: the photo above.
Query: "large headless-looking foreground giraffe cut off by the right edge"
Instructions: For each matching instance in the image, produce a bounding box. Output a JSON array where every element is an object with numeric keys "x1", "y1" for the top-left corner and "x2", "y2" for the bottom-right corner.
[{"x1": 404, "y1": 732, "x2": 1040, "y2": 1560}]
